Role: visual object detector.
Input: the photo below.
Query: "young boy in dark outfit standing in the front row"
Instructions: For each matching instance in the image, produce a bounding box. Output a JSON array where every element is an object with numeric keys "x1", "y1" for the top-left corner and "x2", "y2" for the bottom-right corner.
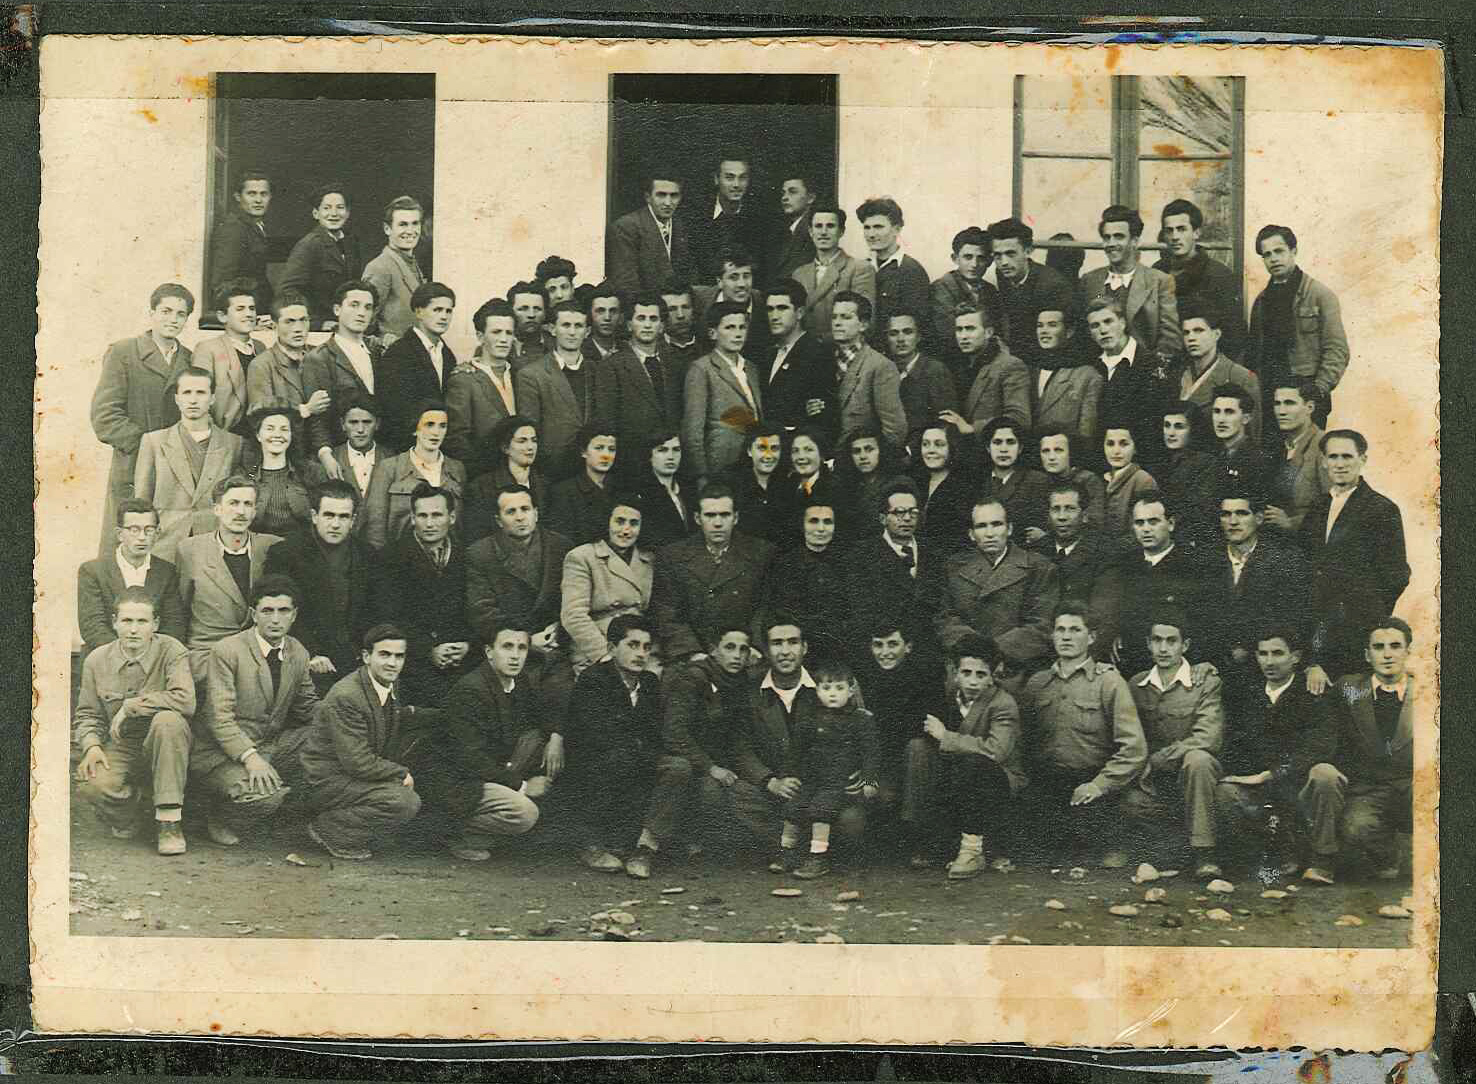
[{"x1": 769, "y1": 660, "x2": 878, "y2": 880}]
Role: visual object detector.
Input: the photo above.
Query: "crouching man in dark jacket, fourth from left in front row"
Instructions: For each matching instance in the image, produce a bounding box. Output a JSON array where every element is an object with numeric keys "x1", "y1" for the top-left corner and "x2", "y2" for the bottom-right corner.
[{"x1": 416, "y1": 623, "x2": 552, "y2": 862}]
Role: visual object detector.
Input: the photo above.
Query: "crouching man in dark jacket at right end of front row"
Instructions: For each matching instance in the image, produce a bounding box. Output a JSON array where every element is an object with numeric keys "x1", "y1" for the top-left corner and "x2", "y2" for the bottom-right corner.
[{"x1": 1302, "y1": 616, "x2": 1417, "y2": 885}]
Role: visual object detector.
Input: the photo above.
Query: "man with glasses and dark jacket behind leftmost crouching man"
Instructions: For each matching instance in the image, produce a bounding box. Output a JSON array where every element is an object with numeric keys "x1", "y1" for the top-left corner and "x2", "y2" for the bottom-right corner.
[{"x1": 77, "y1": 496, "x2": 189, "y2": 659}]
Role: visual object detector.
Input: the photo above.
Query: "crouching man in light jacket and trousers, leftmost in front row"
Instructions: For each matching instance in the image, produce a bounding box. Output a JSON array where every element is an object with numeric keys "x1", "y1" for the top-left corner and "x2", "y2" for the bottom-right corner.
[{"x1": 72, "y1": 588, "x2": 195, "y2": 855}]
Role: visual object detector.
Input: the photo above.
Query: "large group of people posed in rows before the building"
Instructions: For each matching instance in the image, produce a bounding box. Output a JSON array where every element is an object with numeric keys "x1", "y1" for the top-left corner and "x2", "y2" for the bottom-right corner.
[{"x1": 75, "y1": 154, "x2": 1415, "y2": 883}]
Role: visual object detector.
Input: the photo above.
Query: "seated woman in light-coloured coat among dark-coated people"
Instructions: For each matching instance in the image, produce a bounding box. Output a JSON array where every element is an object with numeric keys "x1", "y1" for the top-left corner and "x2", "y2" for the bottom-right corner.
[{"x1": 559, "y1": 493, "x2": 654, "y2": 676}]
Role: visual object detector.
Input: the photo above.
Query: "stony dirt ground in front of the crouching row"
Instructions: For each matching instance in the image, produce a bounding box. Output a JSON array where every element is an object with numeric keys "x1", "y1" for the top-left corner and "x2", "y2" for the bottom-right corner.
[{"x1": 71, "y1": 802, "x2": 1410, "y2": 948}]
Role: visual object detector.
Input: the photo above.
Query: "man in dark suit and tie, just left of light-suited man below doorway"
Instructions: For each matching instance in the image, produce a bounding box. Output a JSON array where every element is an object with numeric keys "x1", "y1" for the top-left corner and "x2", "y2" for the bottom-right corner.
[{"x1": 610, "y1": 289, "x2": 686, "y2": 457}]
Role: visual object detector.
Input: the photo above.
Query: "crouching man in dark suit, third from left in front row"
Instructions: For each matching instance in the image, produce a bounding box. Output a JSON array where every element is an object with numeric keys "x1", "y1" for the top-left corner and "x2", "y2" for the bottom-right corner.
[{"x1": 293, "y1": 623, "x2": 421, "y2": 861}]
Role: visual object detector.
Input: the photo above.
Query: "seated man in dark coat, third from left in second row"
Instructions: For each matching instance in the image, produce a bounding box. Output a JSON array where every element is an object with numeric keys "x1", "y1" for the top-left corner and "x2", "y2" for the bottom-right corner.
[{"x1": 266, "y1": 478, "x2": 372, "y2": 693}]
